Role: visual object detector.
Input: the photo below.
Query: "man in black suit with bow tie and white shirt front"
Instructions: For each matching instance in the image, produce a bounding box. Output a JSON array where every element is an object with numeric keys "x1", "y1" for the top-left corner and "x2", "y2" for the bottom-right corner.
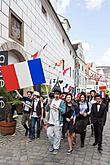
[{"x1": 91, "y1": 94, "x2": 107, "y2": 152}]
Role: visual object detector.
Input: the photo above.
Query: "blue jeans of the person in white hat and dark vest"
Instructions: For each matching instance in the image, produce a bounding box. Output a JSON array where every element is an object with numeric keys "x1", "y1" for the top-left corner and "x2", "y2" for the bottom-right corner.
[{"x1": 31, "y1": 117, "x2": 41, "y2": 138}]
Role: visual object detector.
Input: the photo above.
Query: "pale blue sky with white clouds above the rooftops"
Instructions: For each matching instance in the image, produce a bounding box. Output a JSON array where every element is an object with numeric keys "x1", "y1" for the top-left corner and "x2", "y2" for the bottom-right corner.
[{"x1": 57, "y1": 0, "x2": 110, "y2": 66}]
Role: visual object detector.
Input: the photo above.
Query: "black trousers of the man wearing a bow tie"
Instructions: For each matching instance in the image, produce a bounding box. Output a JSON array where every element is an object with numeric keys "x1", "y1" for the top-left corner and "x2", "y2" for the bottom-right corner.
[{"x1": 93, "y1": 122, "x2": 103, "y2": 146}]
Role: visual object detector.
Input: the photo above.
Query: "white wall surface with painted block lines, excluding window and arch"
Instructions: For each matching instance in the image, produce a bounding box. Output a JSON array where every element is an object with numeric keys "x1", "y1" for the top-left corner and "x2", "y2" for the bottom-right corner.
[{"x1": 0, "y1": 0, "x2": 74, "y2": 89}]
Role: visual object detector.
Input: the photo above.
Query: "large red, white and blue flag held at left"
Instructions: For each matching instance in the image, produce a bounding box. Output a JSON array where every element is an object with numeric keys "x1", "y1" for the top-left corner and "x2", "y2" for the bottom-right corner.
[{"x1": 0, "y1": 58, "x2": 46, "y2": 92}]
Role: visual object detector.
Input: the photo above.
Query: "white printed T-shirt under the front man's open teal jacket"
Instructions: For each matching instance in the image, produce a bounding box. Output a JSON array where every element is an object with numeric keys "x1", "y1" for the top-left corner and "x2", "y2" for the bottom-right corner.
[{"x1": 48, "y1": 99, "x2": 61, "y2": 126}]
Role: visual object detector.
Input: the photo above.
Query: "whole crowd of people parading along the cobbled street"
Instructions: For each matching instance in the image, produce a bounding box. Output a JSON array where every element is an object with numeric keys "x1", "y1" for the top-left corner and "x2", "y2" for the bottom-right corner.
[{"x1": 16, "y1": 84, "x2": 109, "y2": 154}]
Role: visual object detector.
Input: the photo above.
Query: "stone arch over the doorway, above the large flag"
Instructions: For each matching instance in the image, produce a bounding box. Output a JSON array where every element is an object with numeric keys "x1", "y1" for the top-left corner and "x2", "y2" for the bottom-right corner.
[{"x1": 0, "y1": 41, "x2": 28, "y2": 62}]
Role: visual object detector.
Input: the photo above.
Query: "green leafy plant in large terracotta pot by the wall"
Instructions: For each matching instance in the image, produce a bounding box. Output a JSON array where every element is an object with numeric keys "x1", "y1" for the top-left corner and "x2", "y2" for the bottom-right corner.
[{"x1": 0, "y1": 87, "x2": 22, "y2": 135}]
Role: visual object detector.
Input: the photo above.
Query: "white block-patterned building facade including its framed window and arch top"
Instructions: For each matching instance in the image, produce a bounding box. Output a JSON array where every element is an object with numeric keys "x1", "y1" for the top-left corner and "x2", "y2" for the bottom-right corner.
[{"x1": 0, "y1": 0, "x2": 75, "y2": 93}]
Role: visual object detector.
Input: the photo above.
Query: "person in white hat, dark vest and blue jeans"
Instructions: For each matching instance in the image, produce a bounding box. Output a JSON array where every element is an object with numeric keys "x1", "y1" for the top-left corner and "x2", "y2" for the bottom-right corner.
[{"x1": 30, "y1": 91, "x2": 43, "y2": 140}]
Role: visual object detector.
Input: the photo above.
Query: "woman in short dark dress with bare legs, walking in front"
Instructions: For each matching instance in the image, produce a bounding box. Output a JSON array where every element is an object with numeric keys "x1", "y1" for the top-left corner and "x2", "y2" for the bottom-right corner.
[{"x1": 65, "y1": 94, "x2": 76, "y2": 154}]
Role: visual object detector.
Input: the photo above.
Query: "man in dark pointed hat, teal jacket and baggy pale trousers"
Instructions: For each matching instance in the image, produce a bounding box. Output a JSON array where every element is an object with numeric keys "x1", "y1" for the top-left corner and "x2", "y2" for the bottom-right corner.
[{"x1": 46, "y1": 84, "x2": 66, "y2": 154}]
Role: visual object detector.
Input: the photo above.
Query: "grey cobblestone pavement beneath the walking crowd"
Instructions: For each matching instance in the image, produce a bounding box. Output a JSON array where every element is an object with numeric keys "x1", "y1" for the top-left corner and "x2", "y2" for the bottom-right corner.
[{"x1": 0, "y1": 112, "x2": 110, "y2": 165}]
